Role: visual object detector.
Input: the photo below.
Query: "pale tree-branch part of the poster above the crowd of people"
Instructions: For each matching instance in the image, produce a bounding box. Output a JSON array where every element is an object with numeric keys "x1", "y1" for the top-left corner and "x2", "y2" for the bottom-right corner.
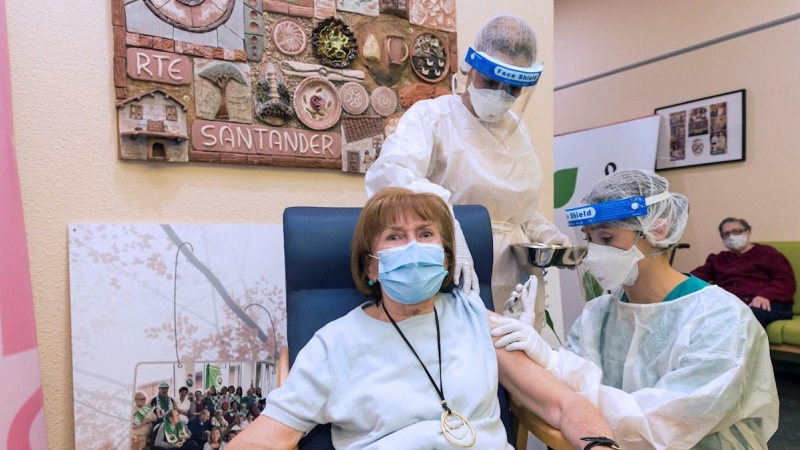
[{"x1": 69, "y1": 224, "x2": 286, "y2": 449}]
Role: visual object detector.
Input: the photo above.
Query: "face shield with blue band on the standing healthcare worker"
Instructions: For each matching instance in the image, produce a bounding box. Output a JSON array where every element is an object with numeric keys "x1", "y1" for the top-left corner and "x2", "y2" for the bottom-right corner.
[{"x1": 453, "y1": 47, "x2": 544, "y2": 140}]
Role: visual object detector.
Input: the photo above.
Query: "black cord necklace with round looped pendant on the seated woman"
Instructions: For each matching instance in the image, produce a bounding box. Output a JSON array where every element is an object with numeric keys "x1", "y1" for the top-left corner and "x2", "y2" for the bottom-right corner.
[{"x1": 380, "y1": 301, "x2": 477, "y2": 447}]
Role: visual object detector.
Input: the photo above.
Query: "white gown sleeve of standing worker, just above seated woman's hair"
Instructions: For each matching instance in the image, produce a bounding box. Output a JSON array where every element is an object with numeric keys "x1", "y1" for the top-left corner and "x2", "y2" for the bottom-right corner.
[{"x1": 364, "y1": 101, "x2": 450, "y2": 204}]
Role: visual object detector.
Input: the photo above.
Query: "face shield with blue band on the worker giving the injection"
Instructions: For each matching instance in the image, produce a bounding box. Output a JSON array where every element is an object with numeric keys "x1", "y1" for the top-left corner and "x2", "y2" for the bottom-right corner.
[{"x1": 566, "y1": 192, "x2": 671, "y2": 301}]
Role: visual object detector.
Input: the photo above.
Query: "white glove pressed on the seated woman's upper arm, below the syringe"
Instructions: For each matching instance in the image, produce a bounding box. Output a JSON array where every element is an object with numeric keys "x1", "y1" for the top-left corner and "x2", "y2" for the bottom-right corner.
[{"x1": 489, "y1": 316, "x2": 559, "y2": 371}]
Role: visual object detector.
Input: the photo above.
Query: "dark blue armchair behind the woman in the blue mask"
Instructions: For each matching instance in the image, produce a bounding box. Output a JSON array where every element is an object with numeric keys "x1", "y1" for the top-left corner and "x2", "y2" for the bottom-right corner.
[{"x1": 283, "y1": 205, "x2": 514, "y2": 450}]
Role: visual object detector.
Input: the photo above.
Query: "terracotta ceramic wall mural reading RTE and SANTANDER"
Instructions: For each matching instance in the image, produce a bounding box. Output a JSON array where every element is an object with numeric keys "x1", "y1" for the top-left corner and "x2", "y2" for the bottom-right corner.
[{"x1": 111, "y1": 0, "x2": 458, "y2": 173}]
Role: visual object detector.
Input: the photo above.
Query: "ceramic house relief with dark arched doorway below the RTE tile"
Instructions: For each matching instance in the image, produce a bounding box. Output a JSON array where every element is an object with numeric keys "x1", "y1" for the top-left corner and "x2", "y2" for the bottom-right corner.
[{"x1": 117, "y1": 89, "x2": 189, "y2": 162}]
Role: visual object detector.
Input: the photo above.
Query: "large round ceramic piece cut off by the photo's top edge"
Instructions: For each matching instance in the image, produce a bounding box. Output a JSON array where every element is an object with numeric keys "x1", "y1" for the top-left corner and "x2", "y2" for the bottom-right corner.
[{"x1": 144, "y1": 0, "x2": 234, "y2": 33}]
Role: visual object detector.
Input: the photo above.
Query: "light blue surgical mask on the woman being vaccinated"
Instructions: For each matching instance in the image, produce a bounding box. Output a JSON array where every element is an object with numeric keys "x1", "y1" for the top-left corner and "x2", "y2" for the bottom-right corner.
[{"x1": 377, "y1": 241, "x2": 448, "y2": 305}]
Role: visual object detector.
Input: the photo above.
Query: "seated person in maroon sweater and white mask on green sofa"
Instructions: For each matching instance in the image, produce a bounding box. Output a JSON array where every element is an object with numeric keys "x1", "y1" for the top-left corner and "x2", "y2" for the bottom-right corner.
[{"x1": 692, "y1": 217, "x2": 797, "y2": 327}]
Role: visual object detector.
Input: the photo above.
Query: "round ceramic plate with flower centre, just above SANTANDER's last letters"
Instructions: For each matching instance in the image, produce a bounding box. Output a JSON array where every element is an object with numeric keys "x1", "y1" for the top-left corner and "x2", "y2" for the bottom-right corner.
[{"x1": 294, "y1": 77, "x2": 342, "y2": 130}]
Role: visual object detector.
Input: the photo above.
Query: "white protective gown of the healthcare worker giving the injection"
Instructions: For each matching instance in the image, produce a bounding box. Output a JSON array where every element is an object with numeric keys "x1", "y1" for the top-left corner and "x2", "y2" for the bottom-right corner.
[{"x1": 552, "y1": 286, "x2": 778, "y2": 450}]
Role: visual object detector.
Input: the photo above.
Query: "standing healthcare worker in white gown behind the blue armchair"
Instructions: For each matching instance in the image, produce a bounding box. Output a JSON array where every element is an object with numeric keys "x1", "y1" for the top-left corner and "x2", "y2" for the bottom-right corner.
[{"x1": 365, "y1": 14, "x2": 568, "y2": 320}]
